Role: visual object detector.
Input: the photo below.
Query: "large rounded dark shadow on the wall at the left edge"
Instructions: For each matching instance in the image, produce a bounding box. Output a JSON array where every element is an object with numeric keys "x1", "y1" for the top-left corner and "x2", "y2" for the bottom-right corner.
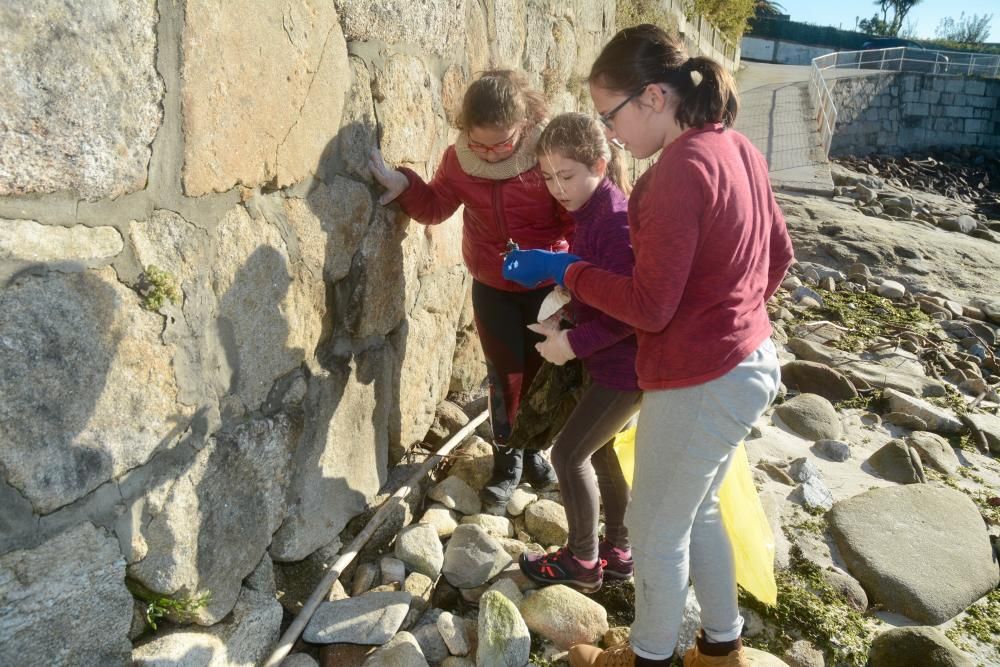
[{"x1": 0, "y1": 265, "x2": 124, "y2": 520}]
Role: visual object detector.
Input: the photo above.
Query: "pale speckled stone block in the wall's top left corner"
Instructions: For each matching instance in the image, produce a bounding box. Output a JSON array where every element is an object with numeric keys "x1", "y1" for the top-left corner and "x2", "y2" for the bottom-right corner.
[{"x1": 0, "y1": 0, "x2": 163, "y2": 200}]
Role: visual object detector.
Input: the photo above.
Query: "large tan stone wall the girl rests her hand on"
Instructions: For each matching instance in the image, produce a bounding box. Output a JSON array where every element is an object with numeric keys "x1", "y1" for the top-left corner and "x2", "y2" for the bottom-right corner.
[{"x1": 0, "y1": 0, "x2": 615, "y2": 665}]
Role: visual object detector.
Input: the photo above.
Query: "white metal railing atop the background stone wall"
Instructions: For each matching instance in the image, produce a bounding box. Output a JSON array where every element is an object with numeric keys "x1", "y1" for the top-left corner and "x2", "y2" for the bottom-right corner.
[{"x1": 809, "y1": 46, "x2": 1000, "y2": 157}]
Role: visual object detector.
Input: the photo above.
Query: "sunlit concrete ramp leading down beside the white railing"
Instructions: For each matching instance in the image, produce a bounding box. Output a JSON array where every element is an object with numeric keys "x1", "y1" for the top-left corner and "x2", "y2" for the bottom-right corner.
[{"x1": 736, "y1": 62, "x2": 833, "y2": 196}]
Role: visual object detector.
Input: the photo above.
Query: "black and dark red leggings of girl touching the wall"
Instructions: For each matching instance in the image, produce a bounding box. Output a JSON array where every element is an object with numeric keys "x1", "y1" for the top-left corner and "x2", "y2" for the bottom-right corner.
[{"x1": 472, "y1": 281, "x2": 552, "y2": 445}]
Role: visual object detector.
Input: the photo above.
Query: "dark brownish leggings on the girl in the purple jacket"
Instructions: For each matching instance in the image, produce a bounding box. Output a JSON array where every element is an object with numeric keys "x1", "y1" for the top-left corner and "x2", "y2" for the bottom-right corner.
[{"x1": 552, "y1": 383, "x2": 642, "y2": 560}]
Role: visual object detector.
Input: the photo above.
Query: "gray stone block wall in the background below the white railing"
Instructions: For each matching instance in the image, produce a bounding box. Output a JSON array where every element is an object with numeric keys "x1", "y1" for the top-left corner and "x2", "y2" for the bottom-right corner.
[{"x1": 830, "y1": 72, "x2": 1000, "y2": 155}]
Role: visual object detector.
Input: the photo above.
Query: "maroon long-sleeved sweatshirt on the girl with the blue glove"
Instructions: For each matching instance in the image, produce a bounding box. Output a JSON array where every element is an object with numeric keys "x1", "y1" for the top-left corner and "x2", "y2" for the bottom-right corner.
[{"x1": 565, "y1": 123, "x2": 794, "y2": 389}]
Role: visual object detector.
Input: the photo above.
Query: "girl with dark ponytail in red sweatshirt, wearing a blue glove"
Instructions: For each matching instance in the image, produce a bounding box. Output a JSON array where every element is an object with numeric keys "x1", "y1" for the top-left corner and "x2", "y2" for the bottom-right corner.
[{"x1": 505, "y1": 25, "x2": 793, "y2": 667}]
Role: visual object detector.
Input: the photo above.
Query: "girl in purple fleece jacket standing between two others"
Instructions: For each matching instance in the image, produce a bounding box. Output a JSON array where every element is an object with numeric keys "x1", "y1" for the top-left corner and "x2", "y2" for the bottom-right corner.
[{"x1": 520, "y1": 113, "x2": 642, "y2": 593}]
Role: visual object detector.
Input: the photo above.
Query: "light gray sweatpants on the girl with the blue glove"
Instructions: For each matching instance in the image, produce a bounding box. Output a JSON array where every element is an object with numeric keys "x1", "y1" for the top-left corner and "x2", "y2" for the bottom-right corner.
[{"x1": 625, "y1": 339, "x2": 780, "y2": 660}]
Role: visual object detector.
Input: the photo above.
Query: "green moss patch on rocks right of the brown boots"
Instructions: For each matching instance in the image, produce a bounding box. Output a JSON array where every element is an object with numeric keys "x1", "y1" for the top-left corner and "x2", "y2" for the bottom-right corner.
[{"x1": 740, "y1": 546, "x2": 874, "y2": 667}]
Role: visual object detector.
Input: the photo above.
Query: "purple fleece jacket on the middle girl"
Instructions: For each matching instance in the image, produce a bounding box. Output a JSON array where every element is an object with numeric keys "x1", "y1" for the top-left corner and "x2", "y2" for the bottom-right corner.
[{"x1": 568, "y1": 178, "x2": 639, "y2": 391}]
